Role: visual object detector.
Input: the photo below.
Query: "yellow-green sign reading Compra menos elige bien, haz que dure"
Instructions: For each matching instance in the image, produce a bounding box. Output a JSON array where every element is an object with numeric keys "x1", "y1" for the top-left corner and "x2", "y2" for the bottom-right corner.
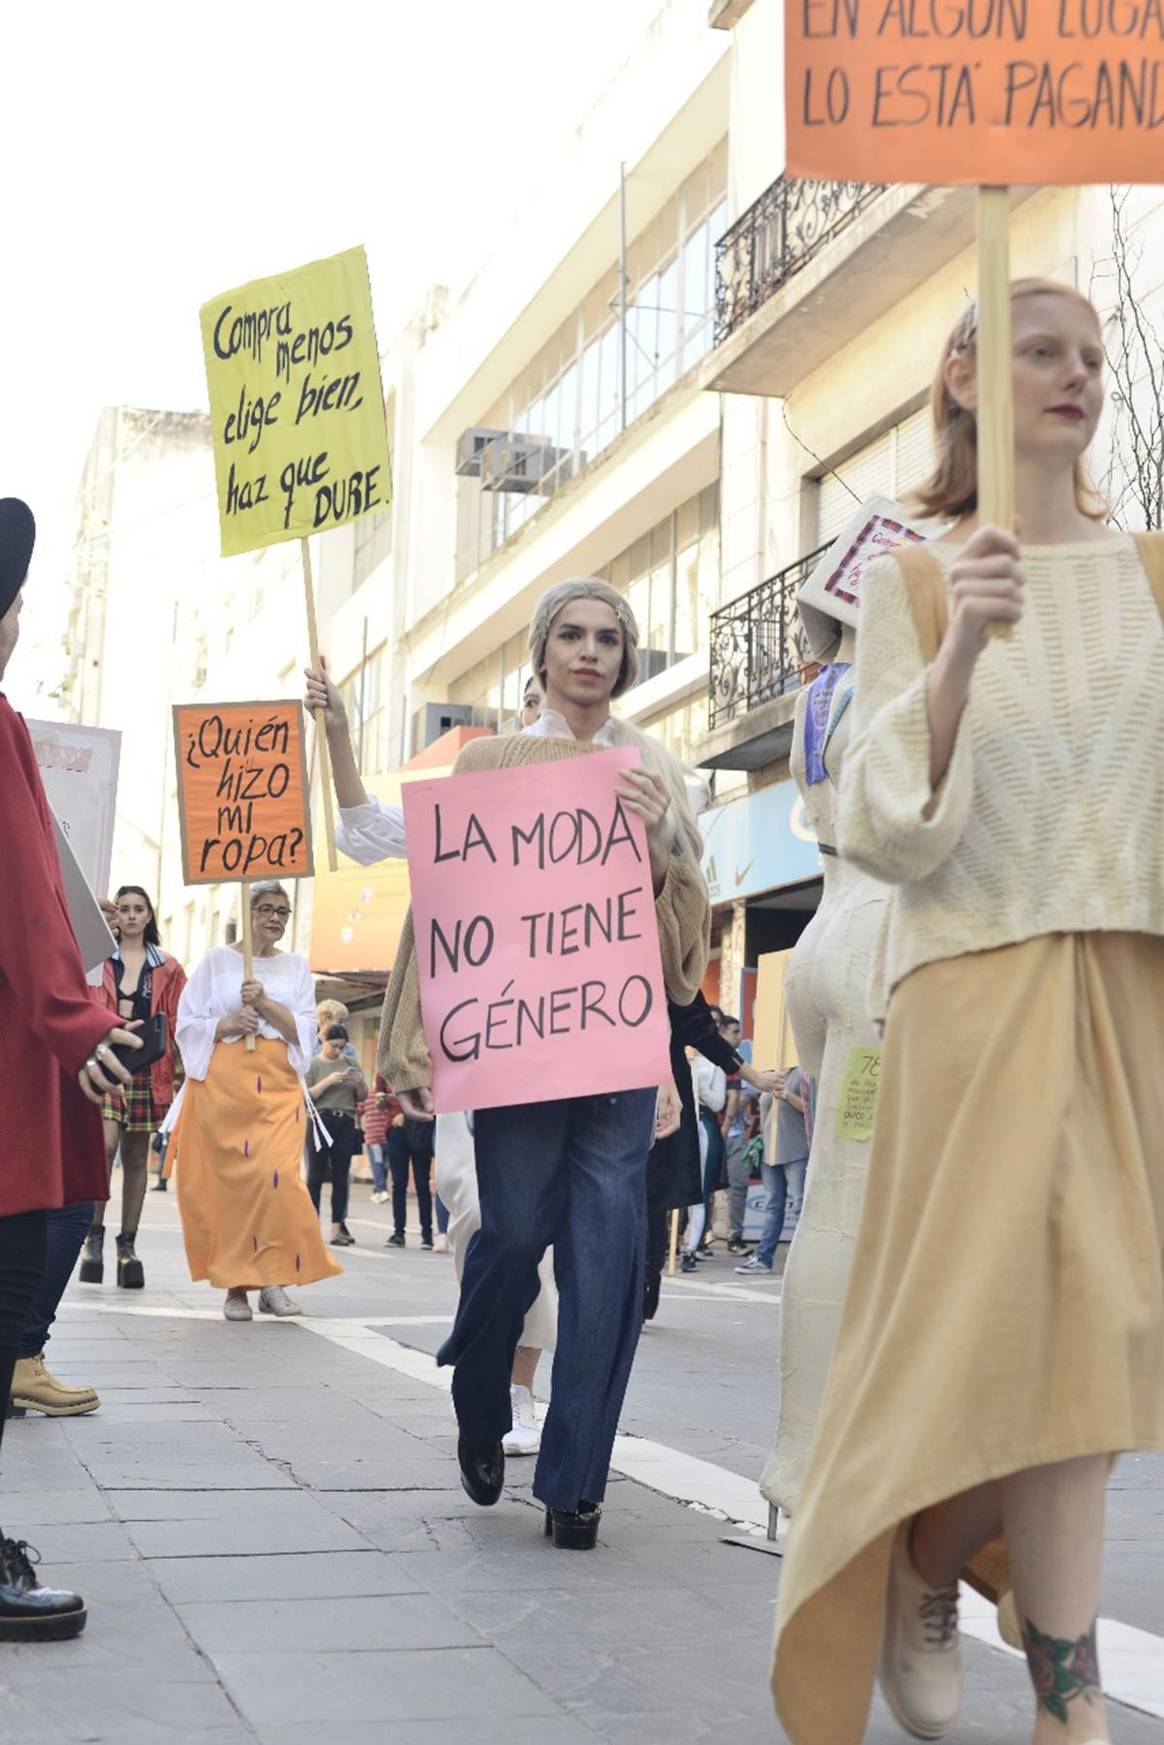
[{"x1": 201, "y1": 248, "x2": 391, "y2": 557}]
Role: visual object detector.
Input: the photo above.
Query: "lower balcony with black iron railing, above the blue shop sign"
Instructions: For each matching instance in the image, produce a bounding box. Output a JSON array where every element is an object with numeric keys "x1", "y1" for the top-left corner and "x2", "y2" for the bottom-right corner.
[{"x1": 700, "y1": 546, "x2": 827, "y2": 770}]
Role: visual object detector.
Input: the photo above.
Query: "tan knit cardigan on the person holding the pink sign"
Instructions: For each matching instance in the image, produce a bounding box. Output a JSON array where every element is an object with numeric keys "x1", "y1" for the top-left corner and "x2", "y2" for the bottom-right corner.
[{"x1": 377, "y1": 733, "x2": 712, "y2": 1091}]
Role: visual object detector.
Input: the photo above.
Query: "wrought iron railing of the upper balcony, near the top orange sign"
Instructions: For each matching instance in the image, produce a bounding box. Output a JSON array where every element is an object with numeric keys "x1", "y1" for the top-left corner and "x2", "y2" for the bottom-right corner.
[{"x1": 716, "y1": 176, "x2": 885, "y2": 346}]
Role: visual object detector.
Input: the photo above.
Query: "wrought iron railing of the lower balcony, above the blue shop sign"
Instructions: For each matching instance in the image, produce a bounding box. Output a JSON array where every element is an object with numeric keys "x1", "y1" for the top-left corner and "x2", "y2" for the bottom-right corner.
[{"x1": 709, "y1": 546, "x2": 827, "y2": 728}]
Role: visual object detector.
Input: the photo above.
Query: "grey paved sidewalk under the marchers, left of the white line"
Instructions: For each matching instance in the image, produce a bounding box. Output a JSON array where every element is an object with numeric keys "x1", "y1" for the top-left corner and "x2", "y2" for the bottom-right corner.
[{"x1": 0, "y1": 1197, "x2": 1159, "y2": 1745}]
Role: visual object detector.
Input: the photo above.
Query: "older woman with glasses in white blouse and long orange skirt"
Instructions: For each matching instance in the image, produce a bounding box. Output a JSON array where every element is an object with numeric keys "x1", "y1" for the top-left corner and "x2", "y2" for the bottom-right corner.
[{"x1": 169, "y1": 881, "x2": 342, "y2": 1321}]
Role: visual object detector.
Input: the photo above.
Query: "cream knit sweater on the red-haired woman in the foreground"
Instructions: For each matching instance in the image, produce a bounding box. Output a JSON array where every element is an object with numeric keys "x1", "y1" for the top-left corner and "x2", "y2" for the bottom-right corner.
[{"x1": 838, "y1": 536, "x2": 1164, "y2": 1021}]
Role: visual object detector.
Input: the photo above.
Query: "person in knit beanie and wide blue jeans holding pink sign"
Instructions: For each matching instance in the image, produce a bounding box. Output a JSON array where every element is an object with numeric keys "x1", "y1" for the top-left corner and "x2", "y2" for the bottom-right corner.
[{"x1": 380, "y1": 579, "x2": 710, "y2": 1550}]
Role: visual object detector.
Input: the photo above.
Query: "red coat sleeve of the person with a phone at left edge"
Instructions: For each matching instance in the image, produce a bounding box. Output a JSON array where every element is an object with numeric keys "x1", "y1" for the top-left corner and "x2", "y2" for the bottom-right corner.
[{"x1": 0, "y1": 696, "x2": 117, "y2": 1073}]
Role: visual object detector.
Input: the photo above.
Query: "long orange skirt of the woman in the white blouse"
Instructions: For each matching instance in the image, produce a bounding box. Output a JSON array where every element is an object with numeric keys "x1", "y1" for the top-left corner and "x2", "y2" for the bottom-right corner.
[{"x1": 169, "y1": 1037, "x2": 344, "y2": 1290}]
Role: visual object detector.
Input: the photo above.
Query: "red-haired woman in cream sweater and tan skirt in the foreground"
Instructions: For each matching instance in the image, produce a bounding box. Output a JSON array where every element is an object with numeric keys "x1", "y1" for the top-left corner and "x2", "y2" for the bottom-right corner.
[{"x1": 773, "y1": 281, "x2": 1164, "y2": 1745}]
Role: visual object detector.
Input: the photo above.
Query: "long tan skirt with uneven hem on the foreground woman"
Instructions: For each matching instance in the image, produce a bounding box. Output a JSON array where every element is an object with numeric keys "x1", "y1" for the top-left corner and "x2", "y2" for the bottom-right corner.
[{"x1": 771, "y1": 934, "x2": 1164, "y2": 1745}]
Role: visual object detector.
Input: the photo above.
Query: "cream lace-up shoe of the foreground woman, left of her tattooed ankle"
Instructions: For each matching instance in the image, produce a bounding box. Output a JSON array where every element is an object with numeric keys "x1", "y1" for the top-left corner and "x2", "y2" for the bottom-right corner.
[{"x1": 881, "y1": 1522, "x2": 962, "y2": 1740}]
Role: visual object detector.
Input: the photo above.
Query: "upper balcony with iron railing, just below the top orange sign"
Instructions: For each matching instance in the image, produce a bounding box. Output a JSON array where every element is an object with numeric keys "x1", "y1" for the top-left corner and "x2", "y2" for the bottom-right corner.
[{"x1": 700, "y1": 176, "x2": 1012, "y2": 396}]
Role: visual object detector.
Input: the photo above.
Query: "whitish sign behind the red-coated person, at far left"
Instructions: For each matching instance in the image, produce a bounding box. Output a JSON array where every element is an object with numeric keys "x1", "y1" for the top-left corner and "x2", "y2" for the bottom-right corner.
[{"x1": 28, "y1": 721, "x2": 120, "y2": 892}]
